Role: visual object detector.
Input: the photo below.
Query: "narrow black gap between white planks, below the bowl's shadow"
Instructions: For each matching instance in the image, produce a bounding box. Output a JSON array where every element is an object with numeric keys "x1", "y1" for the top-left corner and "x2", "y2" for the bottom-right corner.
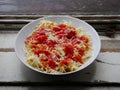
[{"x1": 0, "y1": 81, "x2": 120, "y2": 87}]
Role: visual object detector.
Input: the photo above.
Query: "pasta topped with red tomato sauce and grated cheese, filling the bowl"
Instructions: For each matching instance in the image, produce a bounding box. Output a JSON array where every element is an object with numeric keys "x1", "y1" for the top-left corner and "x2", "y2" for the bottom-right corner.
[{"x1": 24, "y1": 20, "x2": 92, "y2": 73}]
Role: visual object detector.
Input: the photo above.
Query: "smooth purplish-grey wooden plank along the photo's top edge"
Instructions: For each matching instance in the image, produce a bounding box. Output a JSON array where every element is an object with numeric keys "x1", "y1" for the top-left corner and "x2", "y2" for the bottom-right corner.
[{"x1": 0, "y1": 0, "x2": 120, "y2": 15}]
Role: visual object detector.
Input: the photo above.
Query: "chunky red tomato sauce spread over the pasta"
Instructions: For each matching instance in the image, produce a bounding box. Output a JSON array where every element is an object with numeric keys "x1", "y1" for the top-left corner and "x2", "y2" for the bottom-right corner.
[{"x1": 25, "y1": 24, "x2": 89, "y2": 69}]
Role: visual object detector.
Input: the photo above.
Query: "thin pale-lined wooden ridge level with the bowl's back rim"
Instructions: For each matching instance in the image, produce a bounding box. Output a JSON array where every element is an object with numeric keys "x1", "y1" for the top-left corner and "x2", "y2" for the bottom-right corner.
[{"x1": 0, "y1": 14, "x2": 120, "y2": 20}]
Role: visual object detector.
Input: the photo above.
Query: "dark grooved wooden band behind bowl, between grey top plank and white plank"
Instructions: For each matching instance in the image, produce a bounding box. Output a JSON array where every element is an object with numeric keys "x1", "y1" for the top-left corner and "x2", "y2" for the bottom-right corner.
[{"x1": 0, "y1": 15, "x2": 120, "y2": 34}]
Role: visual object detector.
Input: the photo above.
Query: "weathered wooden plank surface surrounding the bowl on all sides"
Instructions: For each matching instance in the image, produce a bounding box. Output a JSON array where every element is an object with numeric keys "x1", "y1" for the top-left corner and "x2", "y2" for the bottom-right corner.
[{"x1": 0, "y1": 0, "x2": 120, "y2": 90}]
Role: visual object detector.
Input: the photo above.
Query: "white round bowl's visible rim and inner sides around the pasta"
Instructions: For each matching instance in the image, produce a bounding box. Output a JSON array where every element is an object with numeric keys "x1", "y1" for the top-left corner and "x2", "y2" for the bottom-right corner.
[{"x1": 15, "y1": 15, "x2": 101, "y2": 75}]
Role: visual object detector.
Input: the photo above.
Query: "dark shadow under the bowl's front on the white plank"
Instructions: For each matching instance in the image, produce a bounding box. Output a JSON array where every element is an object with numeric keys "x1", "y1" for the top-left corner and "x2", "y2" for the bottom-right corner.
[{"x1": 21, "y1": 62, "x2": 96, "y2": 84}]
